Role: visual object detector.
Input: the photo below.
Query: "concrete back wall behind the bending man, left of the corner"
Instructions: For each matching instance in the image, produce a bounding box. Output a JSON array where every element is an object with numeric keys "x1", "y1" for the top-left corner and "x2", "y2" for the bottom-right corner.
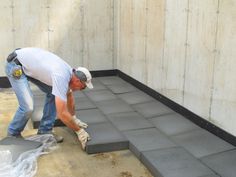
[{"x1": 0, "y1": 0, "x2": 114, "y2": 76}]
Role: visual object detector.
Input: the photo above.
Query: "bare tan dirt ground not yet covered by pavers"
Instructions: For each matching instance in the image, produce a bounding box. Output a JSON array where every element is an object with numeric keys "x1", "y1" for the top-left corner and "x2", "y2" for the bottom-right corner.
[{"x1": 0, "y1": 89, "x2": 152, "y2": 177}]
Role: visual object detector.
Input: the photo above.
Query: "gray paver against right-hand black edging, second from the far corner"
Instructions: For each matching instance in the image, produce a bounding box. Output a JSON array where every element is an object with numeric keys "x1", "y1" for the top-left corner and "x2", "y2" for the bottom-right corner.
[{"x1": 107, "y1": 83, "x2": 137, "y2": 94}]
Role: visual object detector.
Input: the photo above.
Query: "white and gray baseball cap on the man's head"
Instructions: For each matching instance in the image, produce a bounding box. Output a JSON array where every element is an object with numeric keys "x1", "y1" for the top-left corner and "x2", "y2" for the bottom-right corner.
[{"x1": 75, "y1": 67, "x2": 93, "y2": 89}]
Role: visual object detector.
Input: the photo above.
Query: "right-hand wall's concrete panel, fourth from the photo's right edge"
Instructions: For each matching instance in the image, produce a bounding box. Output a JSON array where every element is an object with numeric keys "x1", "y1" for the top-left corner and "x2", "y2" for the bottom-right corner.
[{"x1": 146, "y1": 0, "x2": 165, "y2": 91}]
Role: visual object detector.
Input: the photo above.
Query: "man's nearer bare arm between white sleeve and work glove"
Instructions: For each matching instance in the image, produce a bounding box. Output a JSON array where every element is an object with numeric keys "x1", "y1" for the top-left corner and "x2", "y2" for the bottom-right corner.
[{"x1": 55, "y1": 96, "x2": 80, "y2": 131}]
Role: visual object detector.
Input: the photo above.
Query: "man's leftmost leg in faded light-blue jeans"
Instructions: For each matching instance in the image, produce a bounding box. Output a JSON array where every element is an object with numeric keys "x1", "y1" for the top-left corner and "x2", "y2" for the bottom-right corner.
[{"x1": 6, "y1": 62, "x2": 33, "y2": 137}]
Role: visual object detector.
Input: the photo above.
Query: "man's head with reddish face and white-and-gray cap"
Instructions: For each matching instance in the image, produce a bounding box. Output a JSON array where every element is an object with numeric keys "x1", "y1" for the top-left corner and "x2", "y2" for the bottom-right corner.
[{"x1": 70, "y1": 67, "x2": 93, "y2": 90}]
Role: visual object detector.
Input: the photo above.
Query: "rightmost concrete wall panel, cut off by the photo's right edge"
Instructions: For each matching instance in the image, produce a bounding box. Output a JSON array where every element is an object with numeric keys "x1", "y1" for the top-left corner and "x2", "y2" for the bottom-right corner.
[{"x1": 210, "y1": 0, "x2": 236, "y2": 136}]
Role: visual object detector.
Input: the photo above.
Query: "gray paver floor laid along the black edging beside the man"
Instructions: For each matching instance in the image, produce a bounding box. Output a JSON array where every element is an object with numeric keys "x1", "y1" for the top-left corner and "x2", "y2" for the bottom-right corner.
[{"x1": 32, "y1": 76, "x2": 236, "y2": 177}]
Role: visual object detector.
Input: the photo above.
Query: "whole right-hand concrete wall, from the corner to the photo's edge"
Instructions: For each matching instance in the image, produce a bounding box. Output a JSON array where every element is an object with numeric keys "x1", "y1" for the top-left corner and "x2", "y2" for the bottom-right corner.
[{"x1": 114, "y1": 0, "x2": 236, "y2": 135}]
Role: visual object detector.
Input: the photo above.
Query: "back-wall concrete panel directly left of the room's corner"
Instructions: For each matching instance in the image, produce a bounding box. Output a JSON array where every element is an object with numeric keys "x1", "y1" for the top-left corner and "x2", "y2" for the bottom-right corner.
[{"x1": 83, "y1": 0, "x2": 114, "y2": 70}]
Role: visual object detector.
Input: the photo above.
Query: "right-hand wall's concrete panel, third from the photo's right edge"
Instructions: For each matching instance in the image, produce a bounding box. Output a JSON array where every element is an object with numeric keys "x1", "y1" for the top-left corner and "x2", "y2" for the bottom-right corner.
[{"x1": 162, "y1": 0, "x2": 188, "y2": 104}]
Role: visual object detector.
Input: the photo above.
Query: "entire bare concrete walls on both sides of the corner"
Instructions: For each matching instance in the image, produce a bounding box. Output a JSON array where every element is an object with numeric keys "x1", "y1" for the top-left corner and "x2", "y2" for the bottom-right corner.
[{"x1": 0, "y1": 0, "x2": 236, "y2": 135}]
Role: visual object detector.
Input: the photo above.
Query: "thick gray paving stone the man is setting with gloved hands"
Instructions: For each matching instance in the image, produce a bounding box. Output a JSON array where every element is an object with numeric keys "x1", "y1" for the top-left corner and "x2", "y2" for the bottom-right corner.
[{"x1": 86, "y1": 122, "x2": 129, "y2": 154}]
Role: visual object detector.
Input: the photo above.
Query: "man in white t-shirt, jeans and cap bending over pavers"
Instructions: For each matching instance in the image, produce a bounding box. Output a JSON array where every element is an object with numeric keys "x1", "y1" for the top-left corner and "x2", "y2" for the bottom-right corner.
[{"x1": 6, "y1": 48, "x2": 93, "y2": 149}]
